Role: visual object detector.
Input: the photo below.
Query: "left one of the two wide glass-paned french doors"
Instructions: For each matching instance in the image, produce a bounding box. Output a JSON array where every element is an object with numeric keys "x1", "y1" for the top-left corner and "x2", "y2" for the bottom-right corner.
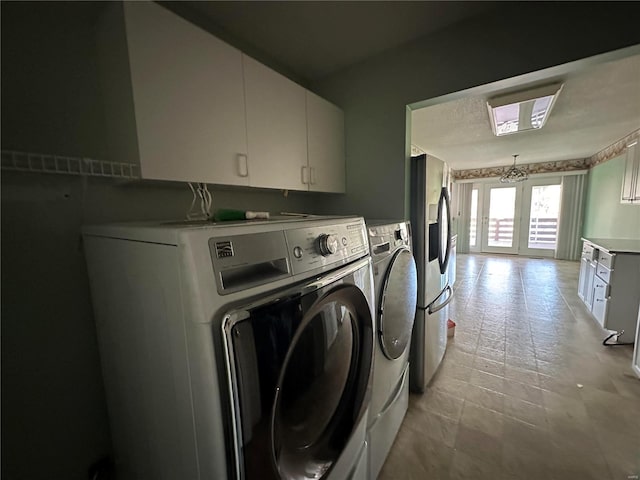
[{"x1": 482, "y1": 185, "x2": 520, "y2": 253}]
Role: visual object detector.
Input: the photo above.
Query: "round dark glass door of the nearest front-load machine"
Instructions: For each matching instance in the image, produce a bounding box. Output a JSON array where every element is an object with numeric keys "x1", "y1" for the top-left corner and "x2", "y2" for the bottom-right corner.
[{"x1": 271, "y1": 285, "x2": 373, "y2": 479}]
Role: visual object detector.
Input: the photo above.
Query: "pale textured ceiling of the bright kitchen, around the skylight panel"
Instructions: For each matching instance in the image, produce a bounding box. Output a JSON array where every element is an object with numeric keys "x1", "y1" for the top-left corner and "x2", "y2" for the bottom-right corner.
[{"x1": 411, "y1": 55, "x2": 640, "y2": 170}]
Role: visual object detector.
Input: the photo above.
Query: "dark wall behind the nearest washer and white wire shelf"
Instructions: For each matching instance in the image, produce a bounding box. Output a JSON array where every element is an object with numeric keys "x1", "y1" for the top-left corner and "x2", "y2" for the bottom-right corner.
[{"x1": 1, "y1": 2, "x2": 320, "y2": 480}]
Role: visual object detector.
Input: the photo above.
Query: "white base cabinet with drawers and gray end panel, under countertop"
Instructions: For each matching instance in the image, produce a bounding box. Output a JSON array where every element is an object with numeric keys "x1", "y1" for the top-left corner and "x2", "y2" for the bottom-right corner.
[{"x1": 578, "y1": 241, "x2": 640, "y2": 343}]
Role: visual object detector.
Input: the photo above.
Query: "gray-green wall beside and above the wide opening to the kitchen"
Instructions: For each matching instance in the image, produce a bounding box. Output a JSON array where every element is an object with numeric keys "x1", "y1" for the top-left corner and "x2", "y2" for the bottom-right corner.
[{"x1": 311, "y1": 2, "x2": 640, "y2": 218}]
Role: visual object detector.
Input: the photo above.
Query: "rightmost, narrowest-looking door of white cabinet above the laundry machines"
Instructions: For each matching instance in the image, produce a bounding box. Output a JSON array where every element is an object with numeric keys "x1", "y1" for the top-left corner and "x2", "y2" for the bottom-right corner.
[{"x1": 307, "y1": 91, "x2": 345, "y2": 193}]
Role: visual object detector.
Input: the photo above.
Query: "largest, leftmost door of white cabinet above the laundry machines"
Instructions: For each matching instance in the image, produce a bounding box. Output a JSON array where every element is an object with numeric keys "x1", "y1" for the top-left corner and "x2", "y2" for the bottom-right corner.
[{"x1": 124, "y1": 2, "x2": 248, "y2": 185}]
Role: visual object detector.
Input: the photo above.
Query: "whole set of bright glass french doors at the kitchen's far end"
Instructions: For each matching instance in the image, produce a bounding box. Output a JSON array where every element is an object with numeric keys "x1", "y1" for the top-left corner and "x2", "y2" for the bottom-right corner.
[{"x1": 469, "y1": 177, "x2": 561, "y2": 257}]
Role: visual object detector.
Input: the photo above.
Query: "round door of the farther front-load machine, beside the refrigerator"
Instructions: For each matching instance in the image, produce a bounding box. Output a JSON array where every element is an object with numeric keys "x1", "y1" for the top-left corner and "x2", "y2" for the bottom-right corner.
[{"x1": 378, "y1": 248, "x2": 418, "y2": 360}]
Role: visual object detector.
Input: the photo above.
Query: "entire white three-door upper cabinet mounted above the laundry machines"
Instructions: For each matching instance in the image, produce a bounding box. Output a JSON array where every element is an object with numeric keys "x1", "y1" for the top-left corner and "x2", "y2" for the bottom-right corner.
[{"x1": 98, "y1": 2, "x2": 345, "y2": 192}]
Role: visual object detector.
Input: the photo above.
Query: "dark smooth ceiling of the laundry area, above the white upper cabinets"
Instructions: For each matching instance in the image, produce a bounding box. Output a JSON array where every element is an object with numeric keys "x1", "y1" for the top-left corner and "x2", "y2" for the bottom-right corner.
[{"x1": 178, "y1": 1, "x2": 497, "y2": 81}]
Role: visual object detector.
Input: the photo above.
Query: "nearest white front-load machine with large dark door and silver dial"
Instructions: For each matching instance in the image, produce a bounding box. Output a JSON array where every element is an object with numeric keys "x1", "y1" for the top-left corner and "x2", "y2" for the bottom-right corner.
[{"x1": 83, "y1": 218, "x2": 375, "y2": 480}]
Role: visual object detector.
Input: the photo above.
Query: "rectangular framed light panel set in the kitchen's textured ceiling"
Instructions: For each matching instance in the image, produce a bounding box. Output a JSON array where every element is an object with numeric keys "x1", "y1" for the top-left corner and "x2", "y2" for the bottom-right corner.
[{"x1": 487, "y1": 83, "x2": 562, "y2": 137}]
